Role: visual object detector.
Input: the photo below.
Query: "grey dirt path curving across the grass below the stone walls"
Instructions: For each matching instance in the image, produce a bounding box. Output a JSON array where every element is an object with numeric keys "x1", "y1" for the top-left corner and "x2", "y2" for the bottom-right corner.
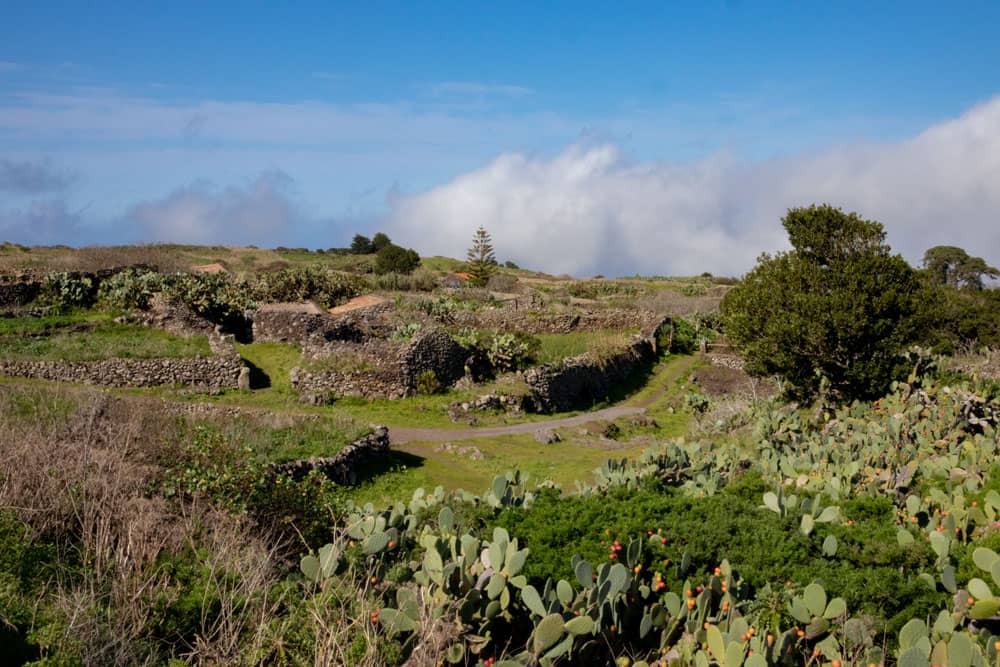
[{"x1": 389, "y1": 357, "x2": 695, "y2": 445}]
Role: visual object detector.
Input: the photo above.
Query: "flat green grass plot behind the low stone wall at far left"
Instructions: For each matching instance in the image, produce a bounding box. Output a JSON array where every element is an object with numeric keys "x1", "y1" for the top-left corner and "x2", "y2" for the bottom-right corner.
[{"x1": 0, "y1": 318, "x2": 212, "y2": 361}]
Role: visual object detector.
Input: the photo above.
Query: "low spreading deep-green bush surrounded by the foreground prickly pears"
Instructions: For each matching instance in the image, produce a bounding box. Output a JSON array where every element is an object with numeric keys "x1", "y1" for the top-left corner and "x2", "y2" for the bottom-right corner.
[{"x1": 496, "y1": 478, "x2": 945, "y2": 632}]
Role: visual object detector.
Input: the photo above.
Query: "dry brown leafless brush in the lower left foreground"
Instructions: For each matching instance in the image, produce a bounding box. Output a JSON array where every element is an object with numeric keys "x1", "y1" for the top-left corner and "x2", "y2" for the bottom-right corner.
[{"x1": 0, "y1": 386, "x2": 290, "y2": 665}]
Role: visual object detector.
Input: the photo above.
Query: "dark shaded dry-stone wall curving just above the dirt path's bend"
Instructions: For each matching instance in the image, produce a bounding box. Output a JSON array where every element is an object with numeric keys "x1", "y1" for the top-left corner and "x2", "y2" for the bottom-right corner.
[{"x1": 524, "y1": 338, "x2": 656, "y2": 412}]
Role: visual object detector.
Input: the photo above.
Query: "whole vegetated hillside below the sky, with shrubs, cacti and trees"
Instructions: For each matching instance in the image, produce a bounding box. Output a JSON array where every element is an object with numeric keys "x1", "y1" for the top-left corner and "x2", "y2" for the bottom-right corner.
[{"x1": 0, "y1": 205, "x2": 1000, "y2": 667}]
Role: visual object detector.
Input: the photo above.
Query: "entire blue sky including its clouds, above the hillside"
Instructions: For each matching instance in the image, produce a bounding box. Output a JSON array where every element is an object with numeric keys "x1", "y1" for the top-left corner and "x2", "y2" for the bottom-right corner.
[{"x1": 0, "y1": 2, "x2": 1000, "y2": 273}]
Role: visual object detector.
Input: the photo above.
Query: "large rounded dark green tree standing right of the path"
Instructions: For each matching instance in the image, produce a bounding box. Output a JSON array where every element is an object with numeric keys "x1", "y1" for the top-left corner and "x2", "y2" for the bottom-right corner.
[{"x1": 721, "y1": 204, "x2": 920, "y2": 400}]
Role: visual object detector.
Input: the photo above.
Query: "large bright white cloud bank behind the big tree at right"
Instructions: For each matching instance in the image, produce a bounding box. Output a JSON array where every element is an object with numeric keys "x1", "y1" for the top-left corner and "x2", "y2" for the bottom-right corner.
[{"x1": 389, "y1": 97, "x2": 1000, "y2": 275}]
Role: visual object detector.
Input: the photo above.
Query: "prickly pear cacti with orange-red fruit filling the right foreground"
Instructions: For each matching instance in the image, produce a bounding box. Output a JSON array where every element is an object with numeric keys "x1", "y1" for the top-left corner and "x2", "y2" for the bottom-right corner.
[{"x1": 301, "y1": 378, "x2": 1000, "y2": 667}]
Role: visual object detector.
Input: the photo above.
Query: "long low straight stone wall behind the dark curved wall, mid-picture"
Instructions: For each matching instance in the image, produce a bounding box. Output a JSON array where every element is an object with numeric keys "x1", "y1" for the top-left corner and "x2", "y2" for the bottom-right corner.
[{"x1": 454, "y1": 309, "x2": 663, "y2": 334}]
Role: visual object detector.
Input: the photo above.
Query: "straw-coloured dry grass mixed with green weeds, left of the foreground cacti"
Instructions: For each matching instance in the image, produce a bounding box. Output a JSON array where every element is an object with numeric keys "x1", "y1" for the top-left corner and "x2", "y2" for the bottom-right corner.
[{"x1": 0, "y1": 385, "x2": 457, "y2": 667}]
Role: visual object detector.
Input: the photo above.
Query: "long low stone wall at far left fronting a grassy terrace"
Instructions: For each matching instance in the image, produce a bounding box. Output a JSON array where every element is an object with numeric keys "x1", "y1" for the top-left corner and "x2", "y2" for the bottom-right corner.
[{"x1": 0, "y1": 336, "x2": 247, "y2": 389}]
